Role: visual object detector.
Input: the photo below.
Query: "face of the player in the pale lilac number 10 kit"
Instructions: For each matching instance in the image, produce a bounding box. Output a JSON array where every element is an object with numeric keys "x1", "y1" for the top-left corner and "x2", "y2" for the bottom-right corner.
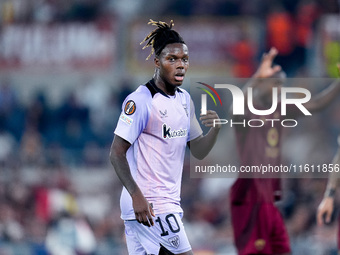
[{"x1": 155, "y1": 43, "x2": 189, "y2": 87}]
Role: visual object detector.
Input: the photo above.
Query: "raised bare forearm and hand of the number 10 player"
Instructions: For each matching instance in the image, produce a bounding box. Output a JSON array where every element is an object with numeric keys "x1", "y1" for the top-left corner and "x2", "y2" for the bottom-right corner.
[{"x1": 188, "y1": 110, "x2": 221, "y2": 159}]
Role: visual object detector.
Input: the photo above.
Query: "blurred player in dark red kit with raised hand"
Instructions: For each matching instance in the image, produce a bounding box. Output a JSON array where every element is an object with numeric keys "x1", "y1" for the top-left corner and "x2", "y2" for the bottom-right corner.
[{"x1": 230, "y1": 48, "x2": 340, "y2": 255}]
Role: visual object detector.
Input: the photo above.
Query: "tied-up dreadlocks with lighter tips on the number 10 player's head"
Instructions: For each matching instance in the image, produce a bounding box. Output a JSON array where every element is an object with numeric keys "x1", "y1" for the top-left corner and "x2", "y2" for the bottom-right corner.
[{"x1": 140, "y1": 19, "x2": 185, "y2": 60}]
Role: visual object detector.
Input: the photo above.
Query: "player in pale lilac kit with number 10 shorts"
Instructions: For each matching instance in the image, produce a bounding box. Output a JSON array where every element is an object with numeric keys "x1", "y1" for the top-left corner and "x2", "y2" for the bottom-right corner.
[{"x1": 110, "y1": 20, "x2": 220, "y2": 255}]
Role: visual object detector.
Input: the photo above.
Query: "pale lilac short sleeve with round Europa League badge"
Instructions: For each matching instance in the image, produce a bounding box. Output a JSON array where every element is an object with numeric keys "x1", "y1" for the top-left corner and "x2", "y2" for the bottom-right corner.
[{"x1": 114, "y1": 90, "x2": 150, "y2": 144}]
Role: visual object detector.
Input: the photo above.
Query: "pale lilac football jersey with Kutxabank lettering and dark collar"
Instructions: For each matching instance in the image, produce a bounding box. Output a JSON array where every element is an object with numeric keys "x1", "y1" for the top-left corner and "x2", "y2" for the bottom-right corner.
[{"x1": 115, "y1": 80, "x2": 202, "y2": 220}]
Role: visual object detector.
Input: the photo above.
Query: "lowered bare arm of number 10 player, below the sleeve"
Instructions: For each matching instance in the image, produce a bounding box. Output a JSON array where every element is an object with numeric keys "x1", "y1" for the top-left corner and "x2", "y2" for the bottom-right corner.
[{"x1": 110, "y1": 135, "x2": 155, "y2": 227}]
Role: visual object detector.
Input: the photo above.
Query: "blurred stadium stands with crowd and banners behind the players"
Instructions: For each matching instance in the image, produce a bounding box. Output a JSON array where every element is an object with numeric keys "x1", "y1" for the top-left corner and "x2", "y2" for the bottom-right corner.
[{"x1": 0, "y1": 0, "x2": 340, "y2": 255}]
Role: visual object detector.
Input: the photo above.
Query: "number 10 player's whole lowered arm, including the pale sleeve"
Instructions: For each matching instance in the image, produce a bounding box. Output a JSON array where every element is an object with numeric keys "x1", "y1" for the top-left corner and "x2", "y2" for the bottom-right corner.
[{"x1": 110, "y1": 86, "x2": 153, "y2": 226}]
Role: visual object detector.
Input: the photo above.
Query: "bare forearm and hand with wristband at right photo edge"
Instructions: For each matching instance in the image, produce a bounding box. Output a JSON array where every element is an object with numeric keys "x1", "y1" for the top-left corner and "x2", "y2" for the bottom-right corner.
[{"x1": 317, "y1": 144, "x2": 340, "y2": 226}]
